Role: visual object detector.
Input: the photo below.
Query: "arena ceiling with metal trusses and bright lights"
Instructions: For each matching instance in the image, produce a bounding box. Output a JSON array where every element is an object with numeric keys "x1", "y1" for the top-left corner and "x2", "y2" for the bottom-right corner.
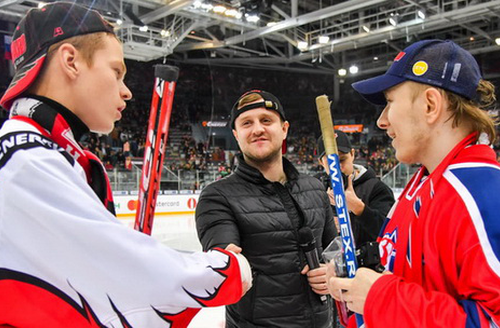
[{"x1": 0, "y1": 0, "x2": 500, "y2": 75}]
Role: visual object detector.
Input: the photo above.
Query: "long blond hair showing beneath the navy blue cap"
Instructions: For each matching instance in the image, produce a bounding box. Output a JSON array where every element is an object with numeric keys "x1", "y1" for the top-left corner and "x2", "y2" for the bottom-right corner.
[{"x1": 412, "y1": 80, "x2": 498, "y2": 144}]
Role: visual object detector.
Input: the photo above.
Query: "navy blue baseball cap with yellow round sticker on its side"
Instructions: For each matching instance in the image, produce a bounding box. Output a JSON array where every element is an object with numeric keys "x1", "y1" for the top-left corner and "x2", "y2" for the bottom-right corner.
[{"x1": 352, "y1": 40, "x2": 482, "y2": 105}]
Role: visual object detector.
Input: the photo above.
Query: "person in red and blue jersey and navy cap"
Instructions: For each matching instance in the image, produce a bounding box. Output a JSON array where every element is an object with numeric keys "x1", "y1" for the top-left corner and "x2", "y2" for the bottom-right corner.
[{"x1": 328, "y1": 40, "x2": 500, "y2": 328}]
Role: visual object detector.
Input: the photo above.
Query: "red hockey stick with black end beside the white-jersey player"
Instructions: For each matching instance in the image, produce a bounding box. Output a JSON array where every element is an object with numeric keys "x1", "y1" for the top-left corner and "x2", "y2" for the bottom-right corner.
[{"x1": 134, "y1": 65, "x2": 179, "y2": 235}]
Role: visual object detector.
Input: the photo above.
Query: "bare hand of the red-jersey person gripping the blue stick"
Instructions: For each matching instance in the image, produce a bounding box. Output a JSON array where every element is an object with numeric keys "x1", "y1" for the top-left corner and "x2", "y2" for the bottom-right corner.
[{"x1": 327, "y1": 268, "x2": 385, "y2": 314}]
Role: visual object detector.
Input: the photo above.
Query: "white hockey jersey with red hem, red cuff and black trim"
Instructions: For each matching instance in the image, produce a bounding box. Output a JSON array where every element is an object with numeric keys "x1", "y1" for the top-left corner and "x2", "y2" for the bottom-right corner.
[{"x1": 0, "y1": 100, "x2": 251, "y2": 328}]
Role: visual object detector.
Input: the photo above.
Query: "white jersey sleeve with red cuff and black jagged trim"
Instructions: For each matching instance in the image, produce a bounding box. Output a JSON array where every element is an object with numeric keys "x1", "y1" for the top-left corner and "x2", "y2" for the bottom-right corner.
[{"x1": 0, "y1": 149, "x2": 246, "y2": 327}]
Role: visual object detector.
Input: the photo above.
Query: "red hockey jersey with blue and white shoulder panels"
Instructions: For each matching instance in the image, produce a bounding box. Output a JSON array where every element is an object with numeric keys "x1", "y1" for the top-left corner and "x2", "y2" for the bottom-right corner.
[{"x1": 356, "y1": 135, "x2": 500, "y2": 328}]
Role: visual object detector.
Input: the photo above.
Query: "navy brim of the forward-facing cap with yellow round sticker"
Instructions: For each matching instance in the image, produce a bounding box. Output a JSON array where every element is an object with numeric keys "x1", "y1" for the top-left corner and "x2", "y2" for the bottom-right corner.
[{"x1": 352, "y1": 74, "x2": 407, "y2": 105}]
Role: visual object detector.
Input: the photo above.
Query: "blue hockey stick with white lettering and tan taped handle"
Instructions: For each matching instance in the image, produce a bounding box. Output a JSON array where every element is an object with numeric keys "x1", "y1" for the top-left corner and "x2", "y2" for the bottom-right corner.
[{"x1": 316, "y1": 95, "x2": 364, "y2": 327}]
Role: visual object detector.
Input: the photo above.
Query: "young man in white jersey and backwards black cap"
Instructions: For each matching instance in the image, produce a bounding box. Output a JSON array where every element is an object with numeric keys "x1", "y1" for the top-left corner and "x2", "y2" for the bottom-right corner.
[{"x1": 0, "y1": 2, "x2": 251, "y2": 328}]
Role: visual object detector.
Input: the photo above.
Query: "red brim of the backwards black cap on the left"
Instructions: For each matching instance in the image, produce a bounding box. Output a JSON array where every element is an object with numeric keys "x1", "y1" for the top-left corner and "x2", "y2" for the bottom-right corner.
[{"x1": 0, "y1": 53, "x2": 46, "y2": 110}]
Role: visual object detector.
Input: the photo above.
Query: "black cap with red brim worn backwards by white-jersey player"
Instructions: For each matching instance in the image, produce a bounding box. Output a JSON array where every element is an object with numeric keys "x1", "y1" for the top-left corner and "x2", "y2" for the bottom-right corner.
[{"x1": 0, "y1": 2, "x2": 114, "y2": 110}]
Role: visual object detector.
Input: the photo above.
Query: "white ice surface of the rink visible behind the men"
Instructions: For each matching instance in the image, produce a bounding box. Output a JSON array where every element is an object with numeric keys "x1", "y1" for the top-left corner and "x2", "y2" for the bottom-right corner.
[{"x1": 119, "y1": 213, "x2": 225, "y2": 328}]
